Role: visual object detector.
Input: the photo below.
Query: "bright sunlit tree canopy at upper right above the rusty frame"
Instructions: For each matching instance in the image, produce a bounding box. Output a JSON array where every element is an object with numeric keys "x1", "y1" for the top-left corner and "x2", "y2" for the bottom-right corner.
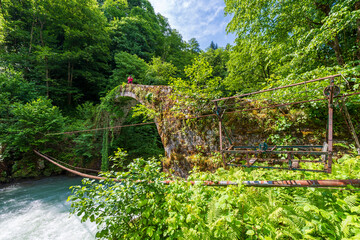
[{"x1": 225, "y1": 0, "x2": 360, "y2": 91}]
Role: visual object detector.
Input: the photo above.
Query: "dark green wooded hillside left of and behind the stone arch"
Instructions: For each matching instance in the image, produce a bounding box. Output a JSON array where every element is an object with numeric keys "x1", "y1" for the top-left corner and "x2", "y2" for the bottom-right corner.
[{"x1": 0, "y1": 0, "x2": 199, "y2": 180}]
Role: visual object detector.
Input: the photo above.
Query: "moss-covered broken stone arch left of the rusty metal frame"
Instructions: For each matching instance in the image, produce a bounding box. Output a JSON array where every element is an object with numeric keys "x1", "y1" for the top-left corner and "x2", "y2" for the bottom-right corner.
[{"x1": 115, "y1": 84, "x2": 218, "y2": 157}]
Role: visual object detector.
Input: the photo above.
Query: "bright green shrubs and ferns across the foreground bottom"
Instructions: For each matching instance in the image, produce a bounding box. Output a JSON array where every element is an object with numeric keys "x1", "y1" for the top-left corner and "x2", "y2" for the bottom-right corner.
[{"x1": 69, "y1": 152, "x2": 360, "y2": 239}]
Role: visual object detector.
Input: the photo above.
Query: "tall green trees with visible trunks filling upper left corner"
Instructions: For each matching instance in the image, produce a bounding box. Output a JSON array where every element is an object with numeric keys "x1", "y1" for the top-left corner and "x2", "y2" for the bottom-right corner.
[{"x1": 2, "y1": 0, "x2": 109, "y2": 104}]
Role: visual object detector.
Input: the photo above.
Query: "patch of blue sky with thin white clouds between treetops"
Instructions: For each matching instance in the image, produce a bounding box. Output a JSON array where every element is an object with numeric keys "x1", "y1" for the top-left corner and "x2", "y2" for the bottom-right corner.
[{"x1": 149, "y1": 0, "x2": 235, "y2": 50}]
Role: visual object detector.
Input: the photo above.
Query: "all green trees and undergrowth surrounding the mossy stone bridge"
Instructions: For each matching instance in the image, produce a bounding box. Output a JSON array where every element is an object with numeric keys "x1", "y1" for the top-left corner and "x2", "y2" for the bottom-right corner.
[{"x1": 0, "y1": 0, "x2": 360, "y2": 239}]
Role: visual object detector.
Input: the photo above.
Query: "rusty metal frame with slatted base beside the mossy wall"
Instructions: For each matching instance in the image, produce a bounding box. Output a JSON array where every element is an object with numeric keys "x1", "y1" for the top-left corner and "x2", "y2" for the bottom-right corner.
[{"x1": 213, "y1": 75, "x2": 340, "y2": 173}]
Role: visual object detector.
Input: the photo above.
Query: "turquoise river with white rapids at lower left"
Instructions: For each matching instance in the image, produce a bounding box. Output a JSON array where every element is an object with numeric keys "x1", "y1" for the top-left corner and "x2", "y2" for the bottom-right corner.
[{"x1": 0, "y1": 176, "x2": 96, "y2": 240}]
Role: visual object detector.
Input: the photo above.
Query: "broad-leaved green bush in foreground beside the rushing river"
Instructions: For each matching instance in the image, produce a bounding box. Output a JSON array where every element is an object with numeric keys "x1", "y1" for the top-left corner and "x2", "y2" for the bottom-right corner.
[{"x1": 69, "y1": 151, "x2": 167, "y2": 239}]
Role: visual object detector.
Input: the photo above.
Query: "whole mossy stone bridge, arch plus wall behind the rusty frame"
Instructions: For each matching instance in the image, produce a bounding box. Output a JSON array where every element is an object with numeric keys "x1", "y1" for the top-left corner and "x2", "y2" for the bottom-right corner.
[{"x1": 115, "y1": 84, "x2": 350, "y2": 176}]
